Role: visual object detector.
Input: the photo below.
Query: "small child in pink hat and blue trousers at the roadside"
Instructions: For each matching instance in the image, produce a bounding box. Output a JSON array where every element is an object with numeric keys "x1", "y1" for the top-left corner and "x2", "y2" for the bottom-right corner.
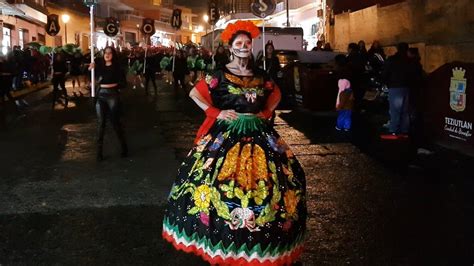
[{"x1": 336, "y1": 79, "x2": 354, "y2": 131}]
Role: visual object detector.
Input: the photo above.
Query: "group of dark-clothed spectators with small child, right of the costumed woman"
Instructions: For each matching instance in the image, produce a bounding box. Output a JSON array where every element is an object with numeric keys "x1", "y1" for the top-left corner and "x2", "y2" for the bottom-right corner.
[{"x1": 336, "y1": 41, "x2": 424, "y2": 140}]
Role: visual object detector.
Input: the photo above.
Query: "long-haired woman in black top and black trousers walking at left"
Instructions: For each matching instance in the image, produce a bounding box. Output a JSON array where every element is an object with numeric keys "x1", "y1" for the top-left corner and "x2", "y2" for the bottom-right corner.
[{"x1": 89, "y1": 46, "x2": 128, "y2": 161}]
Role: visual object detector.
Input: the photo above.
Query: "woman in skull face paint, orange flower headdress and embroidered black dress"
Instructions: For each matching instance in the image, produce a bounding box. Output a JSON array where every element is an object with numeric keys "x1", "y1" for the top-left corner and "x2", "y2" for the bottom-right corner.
[{"x1": 162, "y1": 21, "x2": 307, "y2": 265}]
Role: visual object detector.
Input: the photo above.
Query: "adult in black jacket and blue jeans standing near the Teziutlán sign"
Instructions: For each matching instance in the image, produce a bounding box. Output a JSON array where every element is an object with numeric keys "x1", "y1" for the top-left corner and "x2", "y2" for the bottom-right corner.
[{"x1": 382, "y1": 43, "x2": 414, "y2": 139}]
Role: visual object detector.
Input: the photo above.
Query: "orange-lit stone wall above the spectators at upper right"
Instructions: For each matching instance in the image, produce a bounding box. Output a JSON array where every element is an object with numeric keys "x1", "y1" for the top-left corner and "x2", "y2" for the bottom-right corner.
[{"x1": 329, "y1": 0, "x2": 474, "y2": 72}]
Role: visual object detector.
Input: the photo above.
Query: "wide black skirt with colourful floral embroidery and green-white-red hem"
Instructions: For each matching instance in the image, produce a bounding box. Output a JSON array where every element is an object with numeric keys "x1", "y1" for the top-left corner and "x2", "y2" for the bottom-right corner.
[{"x1": 163, "y1": 116, "x2": 306, "y2": 265}]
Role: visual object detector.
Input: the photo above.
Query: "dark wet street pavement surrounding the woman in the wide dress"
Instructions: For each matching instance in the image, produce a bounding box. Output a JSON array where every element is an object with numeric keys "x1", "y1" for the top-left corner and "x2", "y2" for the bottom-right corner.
[{"x1": 0, "y1": 82, "x2": 474, "y2": 265}]
